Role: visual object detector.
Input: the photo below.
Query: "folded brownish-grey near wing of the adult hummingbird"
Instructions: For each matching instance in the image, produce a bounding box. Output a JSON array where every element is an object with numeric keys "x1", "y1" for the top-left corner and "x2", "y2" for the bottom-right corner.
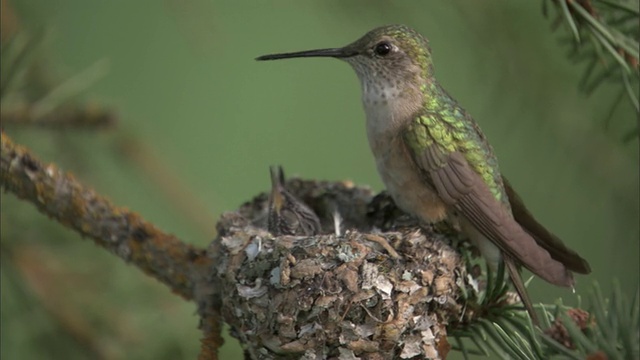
[{"x1": 411, "y1": 142, "x2": 573, "y2": 286}]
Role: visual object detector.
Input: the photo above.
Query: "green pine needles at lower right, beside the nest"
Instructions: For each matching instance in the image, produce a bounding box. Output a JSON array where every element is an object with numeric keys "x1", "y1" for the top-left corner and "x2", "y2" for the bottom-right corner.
[{"x1": 449, "y1": 266, "x2": 640, "y2": 360}]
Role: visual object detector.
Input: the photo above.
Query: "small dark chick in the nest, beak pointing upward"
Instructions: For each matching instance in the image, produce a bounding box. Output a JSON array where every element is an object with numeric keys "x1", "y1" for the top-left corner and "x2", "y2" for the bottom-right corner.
[{"x1": 267, "y1": 166, "x2": 322, "y2": 236}]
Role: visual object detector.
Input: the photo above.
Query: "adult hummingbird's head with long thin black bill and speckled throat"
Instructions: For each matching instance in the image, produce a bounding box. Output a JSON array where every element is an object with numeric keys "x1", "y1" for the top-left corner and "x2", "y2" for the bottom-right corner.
[{"x1": 256, "y1": 25, "x2": 433, "y2": 100}]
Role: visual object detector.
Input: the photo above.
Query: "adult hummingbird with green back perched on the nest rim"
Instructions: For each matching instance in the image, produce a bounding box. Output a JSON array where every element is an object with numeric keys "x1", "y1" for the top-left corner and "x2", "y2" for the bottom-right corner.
[{"x1": 256, "y1": 25, "x2": 591, "y2": 324}]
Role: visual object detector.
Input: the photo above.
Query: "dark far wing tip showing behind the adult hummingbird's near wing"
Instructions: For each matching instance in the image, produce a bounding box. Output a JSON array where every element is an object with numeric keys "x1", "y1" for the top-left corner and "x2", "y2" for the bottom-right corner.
[{"x1": 502, "y1": 176, "x2": 591, "y2": 274}]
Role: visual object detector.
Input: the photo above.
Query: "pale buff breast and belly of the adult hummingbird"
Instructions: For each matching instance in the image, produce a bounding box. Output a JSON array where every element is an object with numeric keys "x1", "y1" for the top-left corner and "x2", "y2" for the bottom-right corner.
[{"x1": 363, "y1": 99, "x2": 447, "y2": 222}]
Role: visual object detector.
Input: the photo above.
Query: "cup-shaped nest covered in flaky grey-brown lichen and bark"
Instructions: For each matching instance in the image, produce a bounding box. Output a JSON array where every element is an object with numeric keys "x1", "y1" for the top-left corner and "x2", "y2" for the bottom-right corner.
[{"x1": 209, "y1": 179, "x2": 465, "y2": 359}]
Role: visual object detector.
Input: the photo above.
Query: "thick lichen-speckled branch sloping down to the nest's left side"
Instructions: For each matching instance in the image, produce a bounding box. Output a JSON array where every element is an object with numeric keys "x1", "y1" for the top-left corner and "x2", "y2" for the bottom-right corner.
[{"x1": 0, "y1": 132, "x2": 211, "y2": 300}]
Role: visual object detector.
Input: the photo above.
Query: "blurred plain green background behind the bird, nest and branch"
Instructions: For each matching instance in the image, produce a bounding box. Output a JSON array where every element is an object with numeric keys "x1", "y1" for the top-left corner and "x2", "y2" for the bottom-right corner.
[{"x1": 0, "y1": 0, "x2": 639, "y2": 359}]
